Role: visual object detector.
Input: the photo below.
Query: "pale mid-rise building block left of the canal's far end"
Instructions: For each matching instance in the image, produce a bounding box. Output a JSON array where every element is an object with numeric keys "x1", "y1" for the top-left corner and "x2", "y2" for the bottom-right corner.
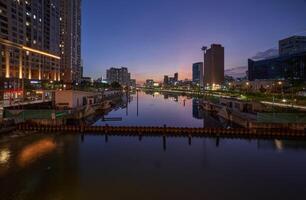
[{"x1": 106, "y1": 67, "x2": 131, "y2": 86}]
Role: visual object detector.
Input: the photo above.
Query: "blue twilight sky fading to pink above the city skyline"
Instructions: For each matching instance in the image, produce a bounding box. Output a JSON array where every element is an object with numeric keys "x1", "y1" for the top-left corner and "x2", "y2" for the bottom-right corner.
[{"x1": 82, "y1": 0, "x2": 306, "y2": 82}]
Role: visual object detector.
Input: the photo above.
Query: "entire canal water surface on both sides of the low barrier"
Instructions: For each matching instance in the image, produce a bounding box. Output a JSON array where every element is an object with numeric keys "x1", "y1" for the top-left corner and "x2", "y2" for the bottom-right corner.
[{"x1": 0, "y1": 94, "x2": 306, "y2": 200}]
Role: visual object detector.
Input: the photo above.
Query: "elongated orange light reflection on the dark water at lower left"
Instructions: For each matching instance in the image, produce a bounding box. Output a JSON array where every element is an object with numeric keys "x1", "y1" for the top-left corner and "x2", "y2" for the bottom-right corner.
[{"x1": 18, "y1": 139, "x2": 56, "y2": 166}]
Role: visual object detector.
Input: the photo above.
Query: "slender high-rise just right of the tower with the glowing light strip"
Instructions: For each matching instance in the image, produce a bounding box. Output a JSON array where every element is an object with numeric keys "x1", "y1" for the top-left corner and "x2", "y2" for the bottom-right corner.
[{"x1": 60, "y1": 0, "x2": 83, "y2": 84}]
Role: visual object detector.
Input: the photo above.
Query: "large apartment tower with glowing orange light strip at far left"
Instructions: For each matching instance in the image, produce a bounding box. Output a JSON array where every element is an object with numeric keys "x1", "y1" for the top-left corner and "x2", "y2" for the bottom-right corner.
[{"x1": 0, "y1": 0, "x2": 61, "y2": 98}]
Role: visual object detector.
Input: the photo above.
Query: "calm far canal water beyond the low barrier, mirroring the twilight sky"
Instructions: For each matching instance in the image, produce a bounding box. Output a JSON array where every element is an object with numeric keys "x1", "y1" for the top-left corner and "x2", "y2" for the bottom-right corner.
[{"x1": 94, "y1": 92, "x2": 234, "y2": 127}]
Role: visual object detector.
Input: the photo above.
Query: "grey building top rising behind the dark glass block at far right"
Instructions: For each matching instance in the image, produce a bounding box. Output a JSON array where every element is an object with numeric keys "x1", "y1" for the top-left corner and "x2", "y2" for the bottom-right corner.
[{"x1": 279, "y1": 36, "x2": 306, "y2": 56}]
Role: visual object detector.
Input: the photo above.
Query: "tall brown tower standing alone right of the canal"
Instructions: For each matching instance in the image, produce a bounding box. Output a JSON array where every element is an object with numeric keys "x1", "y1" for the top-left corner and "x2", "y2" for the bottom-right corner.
[{"x1": 203, "y1": 44, "x2": 224, "y2": 85}]
